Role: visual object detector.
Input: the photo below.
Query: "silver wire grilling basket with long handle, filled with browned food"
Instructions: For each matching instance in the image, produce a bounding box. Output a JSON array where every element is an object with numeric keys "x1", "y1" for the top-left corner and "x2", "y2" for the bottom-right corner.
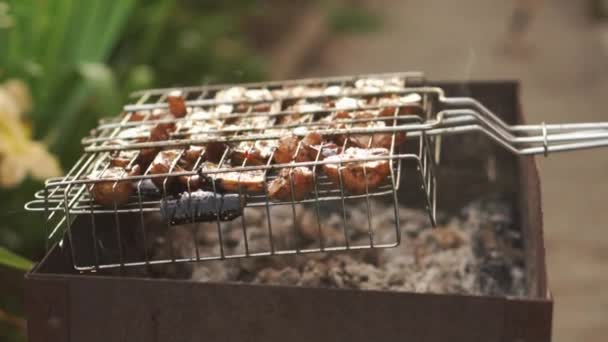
[{"x1": 26, "y1": 73, "x2": 608, "y2": 271}]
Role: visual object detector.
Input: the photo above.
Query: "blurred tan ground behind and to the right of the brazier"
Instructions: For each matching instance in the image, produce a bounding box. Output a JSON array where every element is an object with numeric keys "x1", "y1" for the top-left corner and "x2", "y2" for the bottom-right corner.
[{"x1": 292, "y1": 0, "x2": 608, "y2": 342}]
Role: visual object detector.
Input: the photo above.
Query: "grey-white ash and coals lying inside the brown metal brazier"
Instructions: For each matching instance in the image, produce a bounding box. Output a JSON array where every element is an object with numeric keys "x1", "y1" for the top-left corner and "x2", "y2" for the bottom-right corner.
[{"x1": 150, "y1": 199, "x2": 525, "y2": 296}]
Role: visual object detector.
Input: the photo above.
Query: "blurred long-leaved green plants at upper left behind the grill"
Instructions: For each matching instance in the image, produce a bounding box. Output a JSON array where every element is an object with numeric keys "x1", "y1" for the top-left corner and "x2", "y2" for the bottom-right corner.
[{"x1": 0, "y1": 0, "x2": 264, "y2": 336}]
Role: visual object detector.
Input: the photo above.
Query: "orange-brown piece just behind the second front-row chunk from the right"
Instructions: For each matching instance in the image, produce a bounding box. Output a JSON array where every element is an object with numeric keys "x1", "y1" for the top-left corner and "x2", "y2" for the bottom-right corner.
[{"x1": 274, "y1": 132, "x2": 323, "y2": 164}]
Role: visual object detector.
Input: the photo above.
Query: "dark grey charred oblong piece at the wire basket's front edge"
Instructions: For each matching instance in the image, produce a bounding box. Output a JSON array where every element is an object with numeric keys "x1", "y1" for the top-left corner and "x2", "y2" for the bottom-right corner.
[{"x1": 160, "y1": 190, "x2": 244, "y2": 225}]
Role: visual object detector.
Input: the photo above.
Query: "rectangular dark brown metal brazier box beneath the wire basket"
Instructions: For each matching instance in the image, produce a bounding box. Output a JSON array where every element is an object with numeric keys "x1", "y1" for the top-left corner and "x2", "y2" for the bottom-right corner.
[{"x1": 26, "y1": 78, "x2": 552, "y2": 342}]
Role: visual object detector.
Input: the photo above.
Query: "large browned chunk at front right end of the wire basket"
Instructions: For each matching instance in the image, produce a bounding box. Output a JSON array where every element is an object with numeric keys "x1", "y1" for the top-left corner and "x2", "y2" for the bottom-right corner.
[{"x1": 323, "y1": 147, "x2": 390, "y2": 194}]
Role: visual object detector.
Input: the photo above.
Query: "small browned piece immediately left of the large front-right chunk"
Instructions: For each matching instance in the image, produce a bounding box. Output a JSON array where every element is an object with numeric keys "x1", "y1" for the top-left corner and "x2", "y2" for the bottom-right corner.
[{"x1": 268, "y1": 166, "x2": 314, "y2": 201}]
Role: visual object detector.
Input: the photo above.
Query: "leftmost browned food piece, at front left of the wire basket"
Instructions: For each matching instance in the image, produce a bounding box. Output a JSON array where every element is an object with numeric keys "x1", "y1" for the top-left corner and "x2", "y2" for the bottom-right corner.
[{"x1": 87, "y1": 165, "x2": 141, "y2": 207}]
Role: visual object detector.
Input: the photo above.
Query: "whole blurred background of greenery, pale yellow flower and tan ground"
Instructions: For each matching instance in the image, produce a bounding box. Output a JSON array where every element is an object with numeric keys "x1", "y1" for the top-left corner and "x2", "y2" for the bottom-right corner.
[{"x1": 0, "y1": 0, "x2": 608, "y2": 341}]
